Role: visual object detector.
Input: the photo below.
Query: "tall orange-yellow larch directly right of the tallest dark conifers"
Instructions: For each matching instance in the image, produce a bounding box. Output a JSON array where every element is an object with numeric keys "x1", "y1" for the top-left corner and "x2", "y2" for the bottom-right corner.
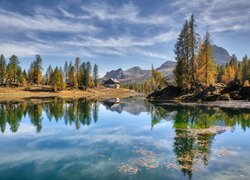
[{"x1": 197, "y1": 32, "x2": 217, "y2": 85}]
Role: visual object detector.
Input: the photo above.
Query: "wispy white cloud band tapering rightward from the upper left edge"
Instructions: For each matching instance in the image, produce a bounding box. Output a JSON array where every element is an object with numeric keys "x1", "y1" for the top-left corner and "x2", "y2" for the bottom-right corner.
[{"x1": 0, "y1": 9, "x2": 98, "y2": 32}]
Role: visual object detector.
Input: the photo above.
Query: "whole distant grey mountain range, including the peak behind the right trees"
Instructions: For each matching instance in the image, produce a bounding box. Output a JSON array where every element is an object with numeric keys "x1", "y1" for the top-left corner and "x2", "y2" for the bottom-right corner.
[{"x1": 102, "y1": 45, "x2": 231, "y2": 84}]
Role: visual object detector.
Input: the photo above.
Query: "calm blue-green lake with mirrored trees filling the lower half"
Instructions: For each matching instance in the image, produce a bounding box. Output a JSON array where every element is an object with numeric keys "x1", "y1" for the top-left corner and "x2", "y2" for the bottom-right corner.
[{"x1": 0, "y1": 98, "x2": 250, "y2": 180}]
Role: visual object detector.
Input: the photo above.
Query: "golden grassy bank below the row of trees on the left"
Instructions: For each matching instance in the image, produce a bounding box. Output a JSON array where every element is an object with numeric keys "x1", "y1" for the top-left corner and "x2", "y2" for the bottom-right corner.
[{"x1": 0, "y1": 86, "x2": 136, "y2": 101}]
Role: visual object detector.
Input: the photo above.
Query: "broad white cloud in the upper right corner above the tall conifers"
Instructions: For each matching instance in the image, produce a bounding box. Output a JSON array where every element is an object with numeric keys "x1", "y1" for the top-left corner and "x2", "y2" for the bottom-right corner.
[{"x1": 172, "y1": 0, "x2": 250, "y2": 33}]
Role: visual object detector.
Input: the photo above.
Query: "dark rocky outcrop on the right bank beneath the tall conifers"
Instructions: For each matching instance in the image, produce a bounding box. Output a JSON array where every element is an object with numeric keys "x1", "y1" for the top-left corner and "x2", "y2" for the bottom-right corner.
[{"x1": 148, "y1": 80, "x2": 250, "y2": 101}]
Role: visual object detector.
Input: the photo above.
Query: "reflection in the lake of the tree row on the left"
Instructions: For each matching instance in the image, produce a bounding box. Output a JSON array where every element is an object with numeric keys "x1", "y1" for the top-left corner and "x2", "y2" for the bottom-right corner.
[{"x1": 0, "y1": 99, "x2": 99, "y2": 133}]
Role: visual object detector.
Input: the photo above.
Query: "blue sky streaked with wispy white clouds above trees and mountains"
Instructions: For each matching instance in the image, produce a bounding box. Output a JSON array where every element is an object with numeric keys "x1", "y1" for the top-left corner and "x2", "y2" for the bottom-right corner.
[{"x1": 0, "y1": 0, "x2": 250, "y2": 76}]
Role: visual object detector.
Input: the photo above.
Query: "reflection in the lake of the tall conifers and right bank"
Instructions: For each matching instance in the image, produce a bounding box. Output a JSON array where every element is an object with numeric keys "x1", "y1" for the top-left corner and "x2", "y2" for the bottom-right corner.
[{"x1": 146, "y1": 103, "x2": 250, "y2": 179}]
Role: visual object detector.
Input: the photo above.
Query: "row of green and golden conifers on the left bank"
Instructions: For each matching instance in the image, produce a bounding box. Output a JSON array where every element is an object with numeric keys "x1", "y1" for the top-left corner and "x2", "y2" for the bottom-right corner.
[{"x1": 0, "y1": 54, "x2": 99, "y2": 91}]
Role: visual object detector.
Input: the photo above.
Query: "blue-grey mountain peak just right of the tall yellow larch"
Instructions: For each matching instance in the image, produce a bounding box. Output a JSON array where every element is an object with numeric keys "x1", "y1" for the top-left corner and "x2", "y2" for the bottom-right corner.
[{"x1": 213, "y1": 45, "x2": 232, "y2": 65}]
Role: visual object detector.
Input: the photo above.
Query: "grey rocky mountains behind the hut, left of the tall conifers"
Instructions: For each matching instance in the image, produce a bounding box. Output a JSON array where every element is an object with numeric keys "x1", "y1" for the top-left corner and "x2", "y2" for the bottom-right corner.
[{"x1": 103, "y1": 61, "x2": 176, "y2": 83}]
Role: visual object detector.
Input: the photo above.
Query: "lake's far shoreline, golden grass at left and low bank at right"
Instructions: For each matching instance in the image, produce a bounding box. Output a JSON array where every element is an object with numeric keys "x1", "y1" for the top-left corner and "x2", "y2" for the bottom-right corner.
[{"x1": 0, "y1": 86, "x2": 250, "y2": 109}]
